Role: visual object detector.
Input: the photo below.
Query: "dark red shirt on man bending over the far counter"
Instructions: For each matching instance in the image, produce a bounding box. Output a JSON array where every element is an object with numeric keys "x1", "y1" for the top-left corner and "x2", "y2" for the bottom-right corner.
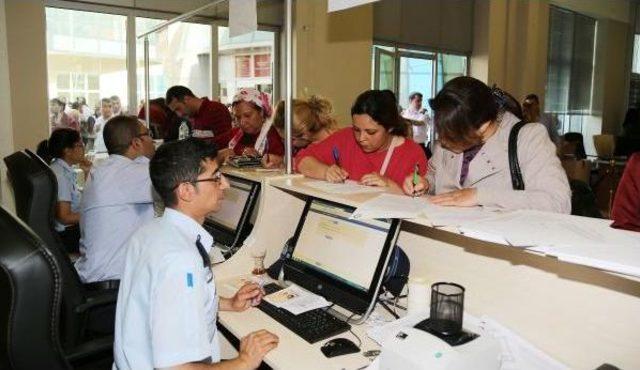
[{"x1": 191, "y1": 98, "x2": 236, "y2": 149}]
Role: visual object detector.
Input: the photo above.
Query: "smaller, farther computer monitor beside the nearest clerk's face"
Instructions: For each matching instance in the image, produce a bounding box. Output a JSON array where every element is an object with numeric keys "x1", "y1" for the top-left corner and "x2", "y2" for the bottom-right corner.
[{"x1": 204, "y1": 175, "x2": 260, "y2": 253}]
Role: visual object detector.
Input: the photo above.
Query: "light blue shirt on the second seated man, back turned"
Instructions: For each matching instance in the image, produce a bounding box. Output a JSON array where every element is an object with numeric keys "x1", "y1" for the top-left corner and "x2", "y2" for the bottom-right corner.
[{"x1": 76, "y1": 154, "x2": 153, "y2": 282}]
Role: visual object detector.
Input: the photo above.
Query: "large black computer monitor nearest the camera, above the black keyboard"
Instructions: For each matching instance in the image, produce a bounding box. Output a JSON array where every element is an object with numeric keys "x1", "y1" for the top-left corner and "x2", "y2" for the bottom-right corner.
[{"x1": 283, "y1": 197, "x2": 399, "y2": 315}]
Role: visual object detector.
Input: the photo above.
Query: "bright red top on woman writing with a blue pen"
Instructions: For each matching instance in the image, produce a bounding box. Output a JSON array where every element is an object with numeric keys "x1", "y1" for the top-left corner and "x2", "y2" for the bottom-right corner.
[{"x1": 295, "y1": 127, "x2": 427, "y2": 186}]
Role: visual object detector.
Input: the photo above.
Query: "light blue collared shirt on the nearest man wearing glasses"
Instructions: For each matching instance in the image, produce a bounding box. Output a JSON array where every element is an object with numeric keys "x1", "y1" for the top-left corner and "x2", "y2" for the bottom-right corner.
[{"x1": 113, "y1": 208, "x2": 220, "y2": 370}]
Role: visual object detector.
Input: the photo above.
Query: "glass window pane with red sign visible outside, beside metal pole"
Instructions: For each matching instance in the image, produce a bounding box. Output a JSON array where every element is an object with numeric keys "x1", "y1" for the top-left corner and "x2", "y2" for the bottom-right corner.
[{"x1": 217, "y1": 27, "x2": 276, "y2": 104}]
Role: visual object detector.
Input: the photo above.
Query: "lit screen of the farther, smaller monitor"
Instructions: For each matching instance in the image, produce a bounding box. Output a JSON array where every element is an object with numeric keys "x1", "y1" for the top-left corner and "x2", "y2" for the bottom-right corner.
[{"x1": 207, "y1": 177, "x2": 251, "y2": 231}]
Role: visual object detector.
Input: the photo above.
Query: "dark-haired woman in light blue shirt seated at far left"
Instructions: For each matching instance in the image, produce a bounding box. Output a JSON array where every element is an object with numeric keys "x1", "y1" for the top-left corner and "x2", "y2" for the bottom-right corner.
[{"x1": 37, "y1": 128, "x2": 91, "y2": 253}]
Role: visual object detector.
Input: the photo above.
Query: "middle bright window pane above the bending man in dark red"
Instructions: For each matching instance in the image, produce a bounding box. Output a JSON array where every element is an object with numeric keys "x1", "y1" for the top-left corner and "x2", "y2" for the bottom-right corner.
[{"x1": 136, "y1": 17, "x2": 211, "y2": 105}]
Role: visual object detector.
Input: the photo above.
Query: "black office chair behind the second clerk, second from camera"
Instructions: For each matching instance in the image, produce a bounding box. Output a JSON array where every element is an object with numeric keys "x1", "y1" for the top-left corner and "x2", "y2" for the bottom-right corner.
[{"x1": 4, "y1": 152, "x2": 118, "y2": 352}]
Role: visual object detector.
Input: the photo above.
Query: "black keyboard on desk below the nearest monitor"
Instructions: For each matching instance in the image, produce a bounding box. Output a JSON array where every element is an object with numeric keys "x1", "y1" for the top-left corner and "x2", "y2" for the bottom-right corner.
[{"x1": 258, "y1": 284, "x2": 351, "y2": 344}]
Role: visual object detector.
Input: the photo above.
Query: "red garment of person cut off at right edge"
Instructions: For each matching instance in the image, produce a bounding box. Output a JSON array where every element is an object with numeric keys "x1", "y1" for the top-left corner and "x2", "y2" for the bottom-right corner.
[{"x1": 611, "y1": 153, "x2": 640, "y2": 231}]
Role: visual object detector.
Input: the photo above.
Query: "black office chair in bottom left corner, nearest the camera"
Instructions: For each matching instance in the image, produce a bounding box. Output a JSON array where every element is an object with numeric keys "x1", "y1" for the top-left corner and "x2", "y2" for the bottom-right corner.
[{"x1": 0, "y1": 207, "x2": 113, "y2": 370}]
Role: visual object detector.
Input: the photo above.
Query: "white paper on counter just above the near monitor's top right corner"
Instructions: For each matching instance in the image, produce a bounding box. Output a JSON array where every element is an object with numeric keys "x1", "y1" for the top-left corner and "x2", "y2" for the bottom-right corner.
[{"x1": 350, "y1": 194, "x2": 425, "y2": 219}]
